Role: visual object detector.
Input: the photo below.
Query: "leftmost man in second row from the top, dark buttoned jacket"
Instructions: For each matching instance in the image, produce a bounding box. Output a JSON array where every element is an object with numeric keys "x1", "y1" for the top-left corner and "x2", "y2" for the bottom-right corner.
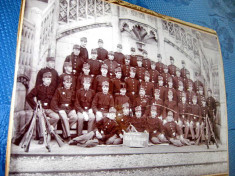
[{"x1": 64, "y1": 45, "x2": 85, "y2": 78}]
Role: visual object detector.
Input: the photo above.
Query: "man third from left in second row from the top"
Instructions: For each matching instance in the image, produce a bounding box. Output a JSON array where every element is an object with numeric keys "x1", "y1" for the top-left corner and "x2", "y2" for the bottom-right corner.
[{"x1": 104, "y1": 51, "x2": 120, "y2": 79}]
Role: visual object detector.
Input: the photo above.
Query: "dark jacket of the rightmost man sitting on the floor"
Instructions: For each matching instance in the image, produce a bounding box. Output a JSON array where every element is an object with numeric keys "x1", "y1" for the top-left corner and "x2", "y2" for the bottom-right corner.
[{"x1": 164, "y1": 121, "x2": 183, "y2": 139}]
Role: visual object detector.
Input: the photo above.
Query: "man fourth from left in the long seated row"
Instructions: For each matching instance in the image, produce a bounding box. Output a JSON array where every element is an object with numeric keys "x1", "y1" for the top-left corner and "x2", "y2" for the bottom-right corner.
[{"x1": 92, "y1": 81, "x2": 114, "y2": 121}]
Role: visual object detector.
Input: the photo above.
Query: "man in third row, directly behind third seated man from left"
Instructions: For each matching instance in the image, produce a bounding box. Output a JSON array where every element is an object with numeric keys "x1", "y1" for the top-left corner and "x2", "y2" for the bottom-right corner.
[{"x1": 76, "y1": 63, "x2": 93, "y2": 90}]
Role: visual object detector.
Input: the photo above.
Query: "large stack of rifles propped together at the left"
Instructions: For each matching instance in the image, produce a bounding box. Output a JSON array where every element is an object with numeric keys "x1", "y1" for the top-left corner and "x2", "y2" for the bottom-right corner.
[{"x1": 13, "y1": 101, "x2": 64, "y2": 152}]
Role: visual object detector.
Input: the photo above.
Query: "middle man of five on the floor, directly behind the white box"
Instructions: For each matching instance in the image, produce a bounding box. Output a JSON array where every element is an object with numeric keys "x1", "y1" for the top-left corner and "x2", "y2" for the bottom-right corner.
[{"x1": 130, "y1": 106, "x2": 147, "y2": 132}]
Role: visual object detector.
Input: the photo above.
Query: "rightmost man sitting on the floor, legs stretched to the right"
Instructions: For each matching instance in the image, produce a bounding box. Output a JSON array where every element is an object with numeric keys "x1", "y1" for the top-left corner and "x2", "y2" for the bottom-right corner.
[{"x1": 164, "y1": 111, "x2": 190, "y2": 147}]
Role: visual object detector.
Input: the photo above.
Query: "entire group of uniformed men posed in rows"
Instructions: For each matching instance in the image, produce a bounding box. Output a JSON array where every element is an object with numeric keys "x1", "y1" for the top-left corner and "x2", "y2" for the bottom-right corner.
[{"x1": 26, "y1": 37, "x2": 216, "y2": 146}]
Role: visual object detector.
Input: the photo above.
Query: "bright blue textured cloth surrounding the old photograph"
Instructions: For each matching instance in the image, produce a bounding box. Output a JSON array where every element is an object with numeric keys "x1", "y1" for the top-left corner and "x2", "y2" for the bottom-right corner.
[{"x1": 0, "y1": 0, "x2": 235, "y2": 175}]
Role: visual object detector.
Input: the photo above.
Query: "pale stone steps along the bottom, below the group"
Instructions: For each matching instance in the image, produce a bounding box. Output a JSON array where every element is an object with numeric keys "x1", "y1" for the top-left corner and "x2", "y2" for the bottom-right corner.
[{"x1": 10, "y1": 141, "x2": 228, "y2": 176}]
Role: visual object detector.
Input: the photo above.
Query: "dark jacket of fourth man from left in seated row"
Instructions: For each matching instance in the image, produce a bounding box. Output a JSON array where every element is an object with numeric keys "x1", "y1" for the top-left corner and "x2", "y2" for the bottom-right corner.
[{"x1": 92, "y1": 92, "x2": 114, "y2": 112}]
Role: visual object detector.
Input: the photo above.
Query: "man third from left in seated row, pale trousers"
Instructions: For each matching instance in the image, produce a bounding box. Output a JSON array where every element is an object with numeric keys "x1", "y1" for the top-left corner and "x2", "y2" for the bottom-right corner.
[{"x1": 74, "y1": 77, "x2": 95, "y2": 136}]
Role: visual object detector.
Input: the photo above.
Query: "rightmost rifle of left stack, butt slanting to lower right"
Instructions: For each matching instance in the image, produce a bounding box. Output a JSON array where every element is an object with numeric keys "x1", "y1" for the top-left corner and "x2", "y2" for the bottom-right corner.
[{"x1": 39, "y1": 102, "x2": 64, "y2": 147}]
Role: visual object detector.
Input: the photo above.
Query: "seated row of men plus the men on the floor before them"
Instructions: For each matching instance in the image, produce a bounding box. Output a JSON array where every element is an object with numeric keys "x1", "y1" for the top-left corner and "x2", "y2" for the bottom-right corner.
[{"x1": 26, "y1": 68, "x2": 211, "y2": 146}]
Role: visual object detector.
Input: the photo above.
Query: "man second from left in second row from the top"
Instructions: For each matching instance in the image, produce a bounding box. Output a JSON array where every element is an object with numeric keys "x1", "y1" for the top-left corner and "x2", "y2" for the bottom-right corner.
[{"x1": 87, "y1": 49, "x2": 102, "y2": 77}]
